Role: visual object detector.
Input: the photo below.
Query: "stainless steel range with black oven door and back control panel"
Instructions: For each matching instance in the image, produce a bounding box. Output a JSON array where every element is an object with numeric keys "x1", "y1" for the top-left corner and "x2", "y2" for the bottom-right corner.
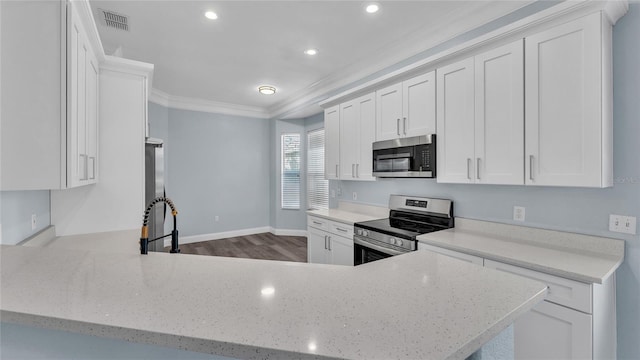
[{"x1": 353, "y1": 195, "x2": 453, "y2": 265}]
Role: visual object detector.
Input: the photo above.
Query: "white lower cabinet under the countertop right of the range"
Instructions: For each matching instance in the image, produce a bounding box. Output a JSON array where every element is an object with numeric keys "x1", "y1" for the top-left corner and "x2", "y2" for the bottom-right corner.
[{"x1": 419, "y1": 243, "x2": 617, "y2": 360}]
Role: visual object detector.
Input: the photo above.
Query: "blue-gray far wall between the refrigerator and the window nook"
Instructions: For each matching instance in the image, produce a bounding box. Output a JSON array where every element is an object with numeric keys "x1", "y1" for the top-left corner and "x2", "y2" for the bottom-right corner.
[{"x1": 164, "y1": 109, "x2": 271, "y2": 236}]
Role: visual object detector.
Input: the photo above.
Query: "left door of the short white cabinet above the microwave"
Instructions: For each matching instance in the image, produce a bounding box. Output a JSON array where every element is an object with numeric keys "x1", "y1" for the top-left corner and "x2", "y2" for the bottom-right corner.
[{"x1": 376, "y1": 83, "x2": 402, "y2": 141}]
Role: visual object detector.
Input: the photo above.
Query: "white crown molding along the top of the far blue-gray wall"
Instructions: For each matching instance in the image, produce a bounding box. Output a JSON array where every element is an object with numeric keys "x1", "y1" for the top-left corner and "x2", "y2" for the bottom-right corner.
[{"x1": 149, "y1": 89, "x2": 270, "y2": 119}]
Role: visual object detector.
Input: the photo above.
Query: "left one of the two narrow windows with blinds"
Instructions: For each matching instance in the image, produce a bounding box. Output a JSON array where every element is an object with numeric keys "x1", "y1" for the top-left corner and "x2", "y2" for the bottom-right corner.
[{"x1": 281, "y1": 134, "x2": 300, "y2": 209}]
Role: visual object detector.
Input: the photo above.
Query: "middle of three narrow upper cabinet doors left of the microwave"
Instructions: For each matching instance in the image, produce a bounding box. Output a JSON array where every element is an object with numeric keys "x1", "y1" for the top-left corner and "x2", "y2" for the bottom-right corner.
[{"x1": 340, "y1": 100, "x2": 360, "y2": 180}]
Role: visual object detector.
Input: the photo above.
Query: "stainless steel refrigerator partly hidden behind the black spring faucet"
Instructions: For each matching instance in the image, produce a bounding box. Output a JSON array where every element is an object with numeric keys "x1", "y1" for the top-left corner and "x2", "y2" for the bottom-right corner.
[{"x1": 144, "y1": 138, "x2": 166, "y2": 251}]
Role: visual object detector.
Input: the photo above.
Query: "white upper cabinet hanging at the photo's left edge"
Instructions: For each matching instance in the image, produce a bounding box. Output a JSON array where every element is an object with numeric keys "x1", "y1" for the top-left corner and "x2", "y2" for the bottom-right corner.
[{"x1": 0, "y1": 1, "x2": 101, "y2": 190}]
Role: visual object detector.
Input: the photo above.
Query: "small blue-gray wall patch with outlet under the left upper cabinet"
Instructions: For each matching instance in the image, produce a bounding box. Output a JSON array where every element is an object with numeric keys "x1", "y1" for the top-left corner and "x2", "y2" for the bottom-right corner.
[{"x1": 0, "y1": 190, "x2": 51, "y2": 245}]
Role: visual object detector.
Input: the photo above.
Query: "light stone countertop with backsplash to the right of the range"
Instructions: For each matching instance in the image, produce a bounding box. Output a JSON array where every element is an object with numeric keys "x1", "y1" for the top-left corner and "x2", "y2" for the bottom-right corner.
[{"x1": 418, "y1": 218, "x2": 624, "y2": 284}]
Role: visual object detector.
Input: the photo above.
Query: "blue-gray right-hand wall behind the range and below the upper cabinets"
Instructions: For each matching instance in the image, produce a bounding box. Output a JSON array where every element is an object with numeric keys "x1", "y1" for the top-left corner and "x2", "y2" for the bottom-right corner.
[{"x1": 330, "y1": 3, "x2": 640, "y2": 359}]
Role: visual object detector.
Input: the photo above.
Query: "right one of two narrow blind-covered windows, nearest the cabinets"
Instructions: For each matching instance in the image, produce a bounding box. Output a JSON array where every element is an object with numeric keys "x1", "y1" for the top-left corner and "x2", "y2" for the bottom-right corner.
[{"x1": 307, "y1": 129, "x2": 329, "y2": 210}]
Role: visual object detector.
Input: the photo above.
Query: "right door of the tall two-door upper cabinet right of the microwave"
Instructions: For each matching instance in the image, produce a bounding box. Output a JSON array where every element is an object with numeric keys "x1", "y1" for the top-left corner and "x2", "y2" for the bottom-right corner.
[{"x1": 474, "y1": 40, "x2": 524, "y2": 185}]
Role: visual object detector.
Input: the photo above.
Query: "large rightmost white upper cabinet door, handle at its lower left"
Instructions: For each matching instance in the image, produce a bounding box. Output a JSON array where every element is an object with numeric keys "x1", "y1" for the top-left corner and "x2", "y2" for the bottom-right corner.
[{"x1": 525, "y1": 13, "x2": 606, "y2": 186}]
